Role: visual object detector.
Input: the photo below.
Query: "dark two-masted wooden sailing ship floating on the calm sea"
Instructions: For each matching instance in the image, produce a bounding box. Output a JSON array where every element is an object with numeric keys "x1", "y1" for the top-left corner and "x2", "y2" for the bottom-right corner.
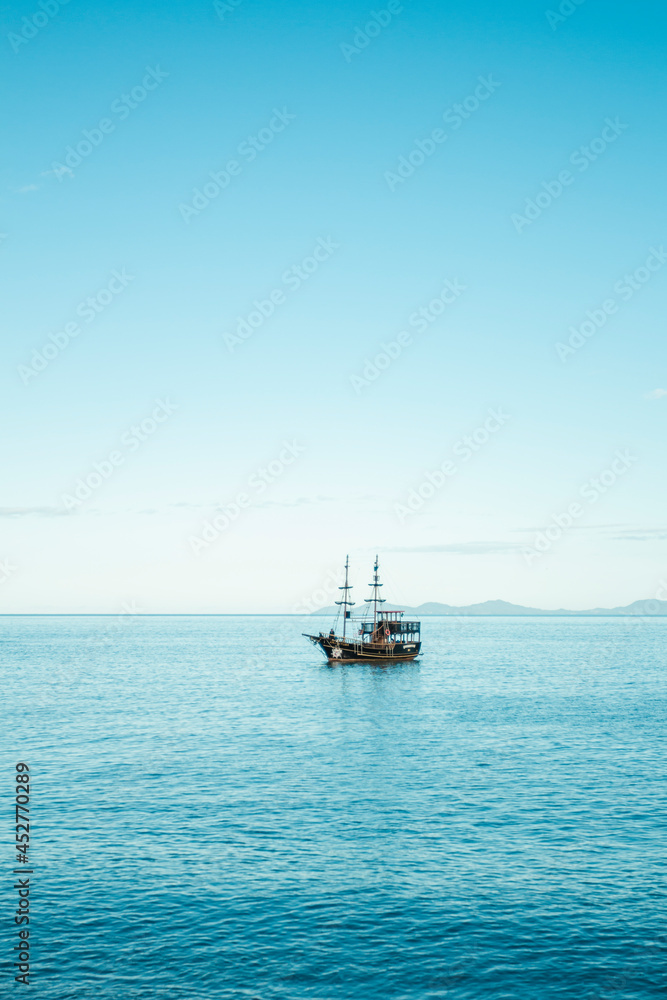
[{"x1": 302, "y1": 556, "x2": 421, "y2": 663}]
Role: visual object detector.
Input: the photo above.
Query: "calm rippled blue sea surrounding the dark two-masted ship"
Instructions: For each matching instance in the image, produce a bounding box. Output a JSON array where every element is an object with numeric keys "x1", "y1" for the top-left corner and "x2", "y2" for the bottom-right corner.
[{"x1": 0, "y1": 617, "x2": 667, "y2": 1000}]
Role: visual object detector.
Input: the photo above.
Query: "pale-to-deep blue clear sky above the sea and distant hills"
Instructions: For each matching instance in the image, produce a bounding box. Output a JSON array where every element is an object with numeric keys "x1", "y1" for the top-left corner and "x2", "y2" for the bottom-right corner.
[{"x1": 0, "y1": 0, "x2": 667, "y2": 613}]
